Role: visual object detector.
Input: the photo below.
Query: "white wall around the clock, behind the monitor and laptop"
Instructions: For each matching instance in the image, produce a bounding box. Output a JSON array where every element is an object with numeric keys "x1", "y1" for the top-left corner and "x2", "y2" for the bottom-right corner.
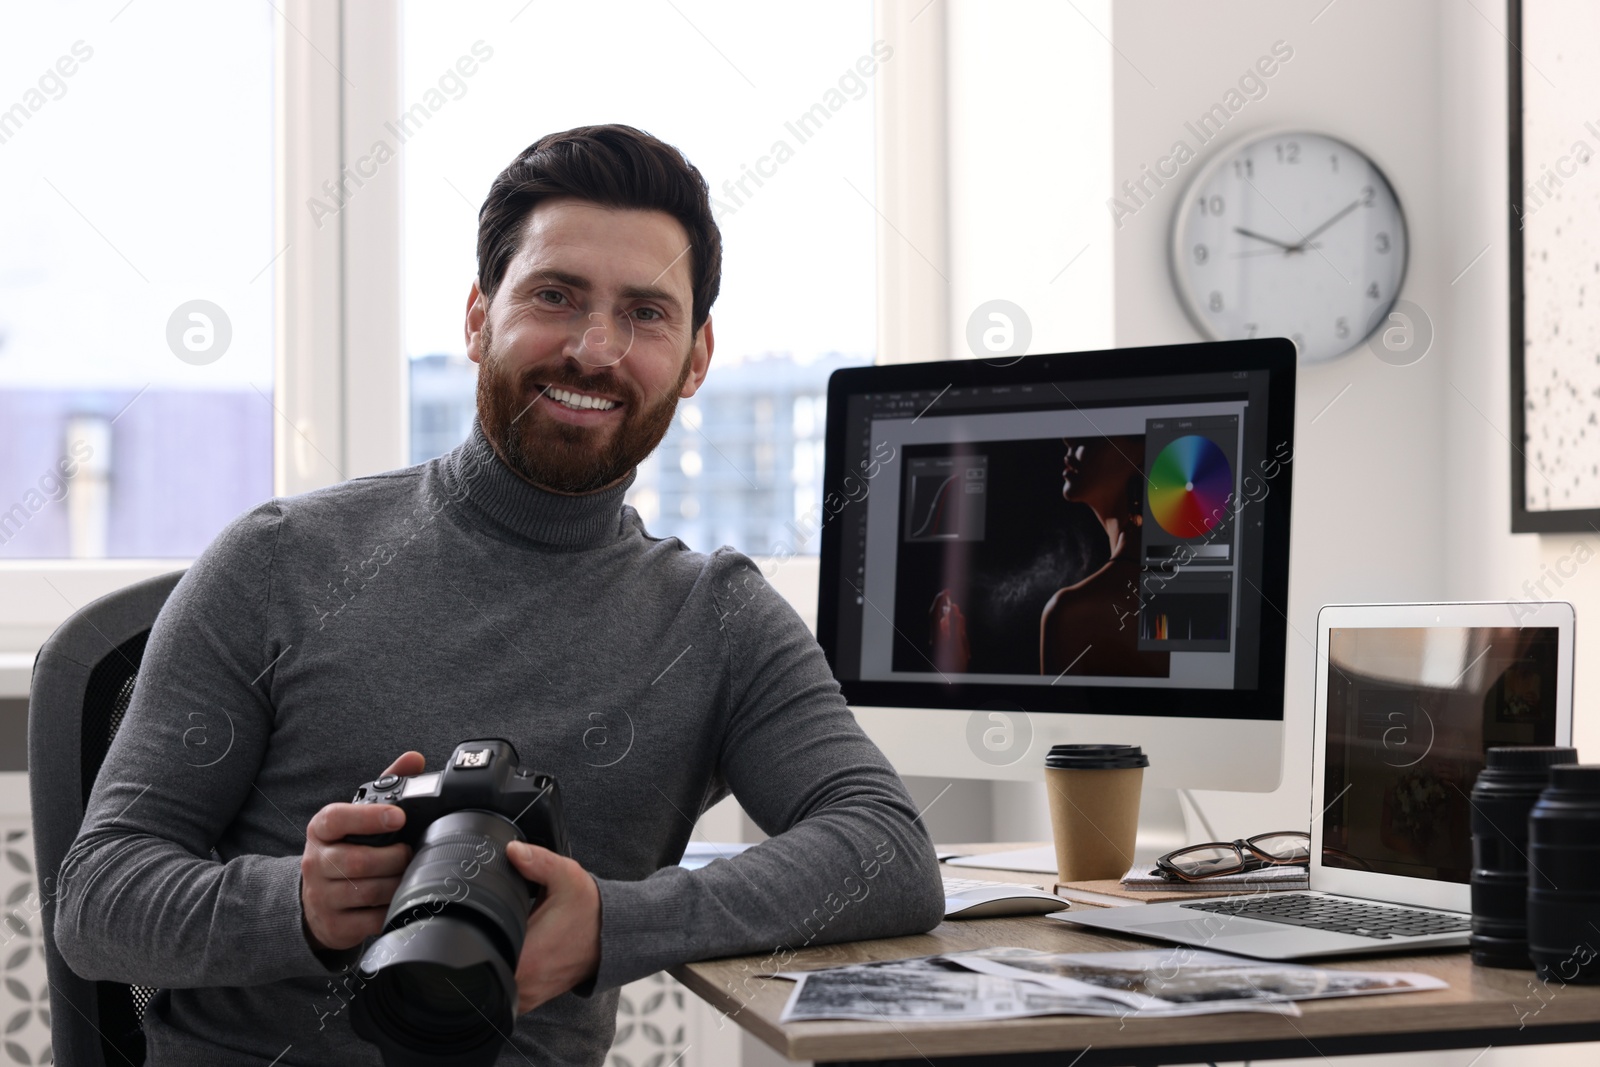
[{"x1": 1114, "y1": 0, "x2": 1600, "y2": 1065}]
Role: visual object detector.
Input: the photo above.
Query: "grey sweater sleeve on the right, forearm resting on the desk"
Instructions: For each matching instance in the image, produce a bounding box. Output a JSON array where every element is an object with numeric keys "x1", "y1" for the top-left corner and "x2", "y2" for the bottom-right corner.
[{"x1": 578, "y1": 550, "x2": 944, "y2": 993}]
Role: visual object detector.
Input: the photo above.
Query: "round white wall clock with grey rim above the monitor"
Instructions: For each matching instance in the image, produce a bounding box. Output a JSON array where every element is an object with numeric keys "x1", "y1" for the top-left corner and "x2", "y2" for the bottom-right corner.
[{"x1": 1171, "y1": 131, "x2": 1406, "y2": 362}]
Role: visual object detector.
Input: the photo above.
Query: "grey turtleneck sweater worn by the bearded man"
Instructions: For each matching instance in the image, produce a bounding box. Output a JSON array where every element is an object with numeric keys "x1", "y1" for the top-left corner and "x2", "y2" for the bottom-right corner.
[{"x1": 56, "y1": 426, "x2": 944, "y2": 1067}]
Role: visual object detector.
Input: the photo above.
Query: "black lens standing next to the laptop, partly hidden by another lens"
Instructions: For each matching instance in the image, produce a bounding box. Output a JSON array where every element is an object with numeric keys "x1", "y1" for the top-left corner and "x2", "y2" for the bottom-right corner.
[{"x1": 1469, "y1": 745, "x2": 1578, "y2": 968}]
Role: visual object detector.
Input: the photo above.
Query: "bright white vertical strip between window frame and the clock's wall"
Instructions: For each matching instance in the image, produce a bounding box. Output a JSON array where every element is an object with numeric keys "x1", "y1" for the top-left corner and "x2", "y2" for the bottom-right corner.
[{"x1": 930, "y1": 0, "x2": 1112, "y2": 358}]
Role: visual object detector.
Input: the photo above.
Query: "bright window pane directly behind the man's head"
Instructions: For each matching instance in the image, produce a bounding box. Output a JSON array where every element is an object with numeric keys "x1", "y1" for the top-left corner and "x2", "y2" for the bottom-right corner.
[{"x1": 403, "y1": 0, "x2": 885, "y2": 555}]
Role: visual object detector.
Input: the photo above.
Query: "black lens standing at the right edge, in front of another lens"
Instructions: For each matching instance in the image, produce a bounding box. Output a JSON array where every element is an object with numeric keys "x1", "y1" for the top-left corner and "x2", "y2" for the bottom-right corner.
[{"x1": 1528, "y1": 763, "x2": 1600, "y2": 982}]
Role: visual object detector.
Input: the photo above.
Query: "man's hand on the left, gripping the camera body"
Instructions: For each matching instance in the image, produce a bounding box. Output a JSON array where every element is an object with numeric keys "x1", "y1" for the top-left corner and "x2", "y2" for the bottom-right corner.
[{"x1": 301, "y1": 752, "x2": 422, "y2": 950}]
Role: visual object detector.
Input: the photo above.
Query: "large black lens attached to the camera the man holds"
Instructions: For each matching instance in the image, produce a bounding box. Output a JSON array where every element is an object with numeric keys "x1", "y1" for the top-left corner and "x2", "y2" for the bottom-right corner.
[{"x1": 352, "y1": 809, "x2": 534, "y2": 1067}]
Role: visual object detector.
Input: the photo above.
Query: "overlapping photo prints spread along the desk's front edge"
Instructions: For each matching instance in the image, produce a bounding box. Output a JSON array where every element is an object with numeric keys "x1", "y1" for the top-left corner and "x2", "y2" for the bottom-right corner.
[{"x1": 779, "y1": 947, "x2": 1445, "y2": 1022}]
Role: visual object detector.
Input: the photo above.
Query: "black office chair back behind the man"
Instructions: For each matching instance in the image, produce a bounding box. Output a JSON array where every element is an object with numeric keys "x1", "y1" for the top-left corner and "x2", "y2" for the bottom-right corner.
[{"x1": 27, "y1": 571, "x2": 182, "y2": 1067}]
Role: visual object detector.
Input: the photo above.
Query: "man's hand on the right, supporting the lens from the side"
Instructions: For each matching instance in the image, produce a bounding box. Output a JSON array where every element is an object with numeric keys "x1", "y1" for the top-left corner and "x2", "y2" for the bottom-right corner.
[{"x1": 506, "y1": 841, "x2": 600, "y2": 1016}]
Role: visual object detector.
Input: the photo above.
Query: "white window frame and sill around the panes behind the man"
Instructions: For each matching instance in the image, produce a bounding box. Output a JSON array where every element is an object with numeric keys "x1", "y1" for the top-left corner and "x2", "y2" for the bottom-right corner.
[{"x1": 0, "y1": 0, "x2": 950, "y2": 697}]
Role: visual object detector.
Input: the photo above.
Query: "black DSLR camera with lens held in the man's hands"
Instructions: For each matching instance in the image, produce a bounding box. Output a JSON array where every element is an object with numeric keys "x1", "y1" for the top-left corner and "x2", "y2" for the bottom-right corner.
[{"x1": 344, "y1": 737, "x2": 571, "y2": 1067}]
